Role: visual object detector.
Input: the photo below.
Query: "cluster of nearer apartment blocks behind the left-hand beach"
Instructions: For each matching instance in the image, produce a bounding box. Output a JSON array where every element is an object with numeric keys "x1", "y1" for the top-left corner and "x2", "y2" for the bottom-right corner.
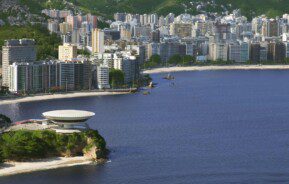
[{"x1": 2, "y1": 39, "x2": 139, "y2": 93}]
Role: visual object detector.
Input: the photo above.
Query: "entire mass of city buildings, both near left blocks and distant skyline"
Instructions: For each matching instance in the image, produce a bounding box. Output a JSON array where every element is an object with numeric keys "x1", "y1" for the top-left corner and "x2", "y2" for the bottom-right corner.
[{"x1": 2, "y1": 10, "x2": 289, "y2": 92}]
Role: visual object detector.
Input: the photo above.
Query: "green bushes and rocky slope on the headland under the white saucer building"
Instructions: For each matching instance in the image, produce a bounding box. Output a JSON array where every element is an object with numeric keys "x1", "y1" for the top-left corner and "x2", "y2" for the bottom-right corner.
[{"x1": 0, "y1": 130, "x2": 108, "y2": 162}]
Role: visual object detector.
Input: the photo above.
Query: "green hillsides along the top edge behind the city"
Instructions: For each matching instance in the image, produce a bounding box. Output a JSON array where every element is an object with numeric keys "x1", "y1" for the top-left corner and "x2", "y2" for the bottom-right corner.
[{"x1": 19, "y1": 0, "x2": 289, "y2": 18}]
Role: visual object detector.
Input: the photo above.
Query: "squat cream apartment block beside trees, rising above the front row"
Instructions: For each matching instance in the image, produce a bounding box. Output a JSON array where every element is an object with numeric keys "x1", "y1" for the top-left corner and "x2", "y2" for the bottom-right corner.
[{"x1": 58, "y1": 43, "x2": 77, "y2": 61}]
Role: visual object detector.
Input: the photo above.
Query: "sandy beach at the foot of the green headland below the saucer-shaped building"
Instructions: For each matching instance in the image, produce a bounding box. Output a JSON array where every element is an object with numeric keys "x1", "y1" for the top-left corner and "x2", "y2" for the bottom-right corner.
[{"x1": 0, "y1": 157, "x2": 93, "y2": 177}]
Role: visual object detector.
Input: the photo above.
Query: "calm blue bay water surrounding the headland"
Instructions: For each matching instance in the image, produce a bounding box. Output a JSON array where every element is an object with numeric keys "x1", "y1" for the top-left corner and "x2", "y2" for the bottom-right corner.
[{"x1": 0, "y1": 70, "x2": 289, "y2": 184}]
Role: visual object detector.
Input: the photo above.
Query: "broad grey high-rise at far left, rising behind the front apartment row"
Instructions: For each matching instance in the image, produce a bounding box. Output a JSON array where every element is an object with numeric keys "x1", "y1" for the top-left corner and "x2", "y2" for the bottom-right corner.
[{"x1": 2, "y1": 39, "x2": 36, "y2": 87}]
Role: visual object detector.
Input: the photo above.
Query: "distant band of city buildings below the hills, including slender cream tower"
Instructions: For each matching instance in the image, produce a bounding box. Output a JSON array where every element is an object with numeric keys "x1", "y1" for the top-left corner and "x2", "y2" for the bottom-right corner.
[{"x1": 45, "y1": 10, "x2": 289, "y2": 64}]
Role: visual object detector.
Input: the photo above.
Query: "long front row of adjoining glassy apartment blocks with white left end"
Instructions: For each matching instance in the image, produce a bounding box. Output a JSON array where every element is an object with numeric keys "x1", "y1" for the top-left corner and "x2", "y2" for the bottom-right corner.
[{"x1": 9, "y1": 62, "x2": 92, "y2": 92}]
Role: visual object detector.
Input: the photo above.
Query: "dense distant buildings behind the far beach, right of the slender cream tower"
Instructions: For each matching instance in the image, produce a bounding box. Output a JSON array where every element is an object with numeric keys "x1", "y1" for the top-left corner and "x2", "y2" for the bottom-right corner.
[{"x1": 105, "y1": 10, "x2": 289, "y2": 63}]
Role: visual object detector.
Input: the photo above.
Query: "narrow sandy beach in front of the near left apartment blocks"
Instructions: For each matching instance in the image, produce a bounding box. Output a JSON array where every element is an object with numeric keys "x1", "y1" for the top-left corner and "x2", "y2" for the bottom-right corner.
[{"x1": 0, "y1": 92, "x2": 129, "y2": 105}]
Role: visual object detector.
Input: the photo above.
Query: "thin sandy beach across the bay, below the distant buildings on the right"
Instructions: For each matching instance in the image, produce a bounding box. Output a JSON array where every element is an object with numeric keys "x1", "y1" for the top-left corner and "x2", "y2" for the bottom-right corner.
[{"x1": 143, "y1": 65, "x2": 289, "y2": 74}]
